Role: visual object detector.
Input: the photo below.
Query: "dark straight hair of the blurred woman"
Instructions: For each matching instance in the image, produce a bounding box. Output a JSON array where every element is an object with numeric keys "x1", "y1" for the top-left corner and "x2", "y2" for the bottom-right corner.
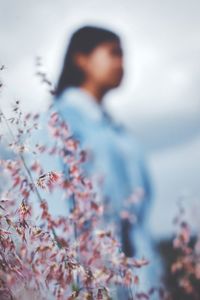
[{"x1": 55, "y1": 26, "x2": 120, "y2": 97}]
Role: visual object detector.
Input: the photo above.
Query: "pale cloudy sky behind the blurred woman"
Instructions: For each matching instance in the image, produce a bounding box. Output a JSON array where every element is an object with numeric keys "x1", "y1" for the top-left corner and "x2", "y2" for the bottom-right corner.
[{"x1": 0, "y1": 0, "x2": 200, "y2": 238}]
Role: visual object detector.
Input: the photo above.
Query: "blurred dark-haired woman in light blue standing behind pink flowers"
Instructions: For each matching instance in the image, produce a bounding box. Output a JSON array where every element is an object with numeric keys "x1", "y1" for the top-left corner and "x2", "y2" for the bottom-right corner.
[{"x1": 41, "y1": 26, "x2": 160, "y2": 300}]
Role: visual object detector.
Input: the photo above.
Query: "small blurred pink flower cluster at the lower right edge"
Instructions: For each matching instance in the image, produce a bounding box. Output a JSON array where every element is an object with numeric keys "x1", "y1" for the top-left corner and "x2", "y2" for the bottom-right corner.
[{"x1": 171, "y1": 198, "x2": 200, "y2": 299}]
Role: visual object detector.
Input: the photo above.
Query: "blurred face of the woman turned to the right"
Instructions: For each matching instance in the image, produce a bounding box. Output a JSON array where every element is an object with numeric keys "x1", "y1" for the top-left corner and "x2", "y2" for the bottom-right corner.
[{"x1": 74, "y1": 41, "x2": 124, "y2": 89}]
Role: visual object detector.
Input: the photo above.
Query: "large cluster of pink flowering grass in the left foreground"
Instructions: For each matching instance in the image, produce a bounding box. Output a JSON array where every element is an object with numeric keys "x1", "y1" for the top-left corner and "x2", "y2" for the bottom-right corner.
[{"x1": 0, "y1": 96, "x2": 152, "y2": 300}]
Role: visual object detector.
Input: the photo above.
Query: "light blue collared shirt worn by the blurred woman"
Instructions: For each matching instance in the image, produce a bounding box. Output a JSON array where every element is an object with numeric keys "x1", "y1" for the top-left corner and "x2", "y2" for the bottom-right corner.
[{"x1": 54, "y1": 87, "x2": 152, "y2": 230}]
